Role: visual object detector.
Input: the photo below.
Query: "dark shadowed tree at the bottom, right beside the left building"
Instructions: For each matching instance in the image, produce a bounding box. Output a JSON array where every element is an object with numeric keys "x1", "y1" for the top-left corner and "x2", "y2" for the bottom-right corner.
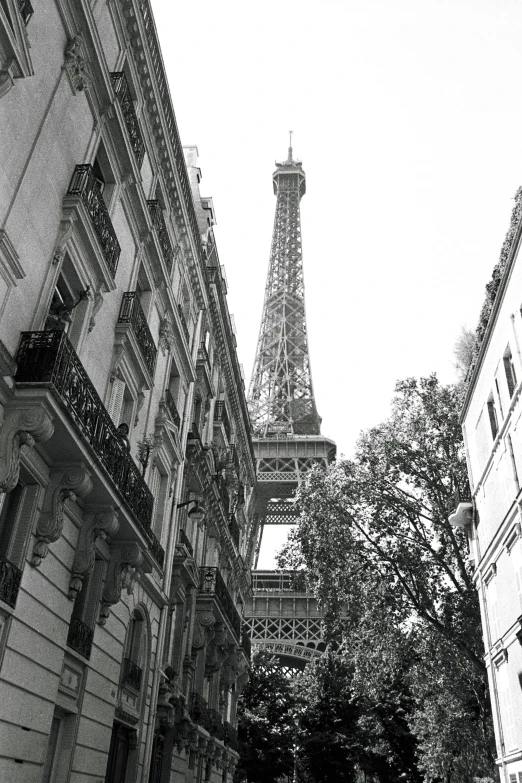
[{"x1": 234, "y1": 651, "x2": 295, "y2": 783}]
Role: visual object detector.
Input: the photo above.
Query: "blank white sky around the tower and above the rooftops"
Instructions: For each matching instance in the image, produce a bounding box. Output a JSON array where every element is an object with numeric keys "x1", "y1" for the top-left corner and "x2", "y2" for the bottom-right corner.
[{"x1": 152, "y1": 0, "x2": 522, "y2": 564}]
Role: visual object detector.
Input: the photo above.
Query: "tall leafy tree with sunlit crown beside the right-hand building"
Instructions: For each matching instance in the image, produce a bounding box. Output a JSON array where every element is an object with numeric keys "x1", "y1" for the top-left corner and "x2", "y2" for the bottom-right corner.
[{"x1": 280, "y1": 375, "x2": 494, "y2": 783}]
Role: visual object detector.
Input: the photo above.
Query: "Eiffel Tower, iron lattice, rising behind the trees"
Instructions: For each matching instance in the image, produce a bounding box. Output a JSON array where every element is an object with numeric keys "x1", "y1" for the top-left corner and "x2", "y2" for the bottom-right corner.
[{"x1": 246, "y1": 139, "x2": 336, "y2": 672}]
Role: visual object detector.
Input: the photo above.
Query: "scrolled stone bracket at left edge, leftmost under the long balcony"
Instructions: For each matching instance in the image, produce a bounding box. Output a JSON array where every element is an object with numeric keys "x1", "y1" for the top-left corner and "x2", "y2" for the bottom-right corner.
[{"x1": 0, "y1": 405, "x2": 54, "y2": 492}]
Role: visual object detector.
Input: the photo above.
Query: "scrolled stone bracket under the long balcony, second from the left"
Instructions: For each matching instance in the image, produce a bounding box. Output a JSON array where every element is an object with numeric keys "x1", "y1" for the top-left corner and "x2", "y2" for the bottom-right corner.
[{"x1": 31, "y1": 466, "x2": 92, "y2": 567}]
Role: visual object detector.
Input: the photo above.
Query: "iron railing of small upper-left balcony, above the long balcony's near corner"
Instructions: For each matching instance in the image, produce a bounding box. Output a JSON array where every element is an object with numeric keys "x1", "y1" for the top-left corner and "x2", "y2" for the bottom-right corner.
[{"x1": 67, "y1": 163, "x2": 121, "y2": 277}]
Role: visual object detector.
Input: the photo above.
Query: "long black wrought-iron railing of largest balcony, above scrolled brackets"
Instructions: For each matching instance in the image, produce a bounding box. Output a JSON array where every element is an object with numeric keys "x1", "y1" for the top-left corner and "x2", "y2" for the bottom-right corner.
[{"x1": 15, "y1": 331, "x2": 154, "y2": 540}]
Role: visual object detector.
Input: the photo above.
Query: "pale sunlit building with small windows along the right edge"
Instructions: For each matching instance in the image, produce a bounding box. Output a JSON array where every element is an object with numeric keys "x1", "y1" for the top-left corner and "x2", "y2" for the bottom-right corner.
[{"x1": 456, "y1": 191, "x2": 522, "y2": 783}]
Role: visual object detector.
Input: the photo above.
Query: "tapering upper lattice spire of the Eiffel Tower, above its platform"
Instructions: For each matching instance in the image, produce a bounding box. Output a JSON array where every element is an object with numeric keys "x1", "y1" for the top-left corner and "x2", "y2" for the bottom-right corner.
[{"x1": 249, "y1": 147, "x2": 321, "y2": 437}]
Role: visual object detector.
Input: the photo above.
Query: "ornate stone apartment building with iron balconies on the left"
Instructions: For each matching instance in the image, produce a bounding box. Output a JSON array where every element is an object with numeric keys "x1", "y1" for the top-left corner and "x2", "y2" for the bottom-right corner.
[{"x1": 0, "y1": 0, "x2": 254, "y2": 783}]
